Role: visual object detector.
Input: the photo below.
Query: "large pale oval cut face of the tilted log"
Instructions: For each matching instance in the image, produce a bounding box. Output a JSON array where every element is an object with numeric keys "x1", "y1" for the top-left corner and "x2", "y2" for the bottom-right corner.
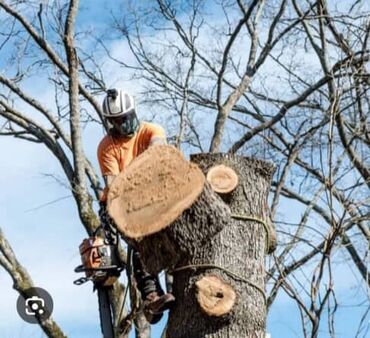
[{"x1": 108, "y1": 145, "x2": 205, "y2": 239}]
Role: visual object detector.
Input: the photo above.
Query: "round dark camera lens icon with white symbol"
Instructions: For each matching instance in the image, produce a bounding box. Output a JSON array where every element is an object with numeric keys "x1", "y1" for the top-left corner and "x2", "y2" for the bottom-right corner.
[{"x1": 17, "y1": 288, "x2": 54, "y2": 324}]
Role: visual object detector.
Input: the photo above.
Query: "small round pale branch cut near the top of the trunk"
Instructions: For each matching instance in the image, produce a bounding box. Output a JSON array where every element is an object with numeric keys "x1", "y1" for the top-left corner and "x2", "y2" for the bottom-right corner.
[{"x1": 207, "y1": 164, "x2": 239, "y2": 194}]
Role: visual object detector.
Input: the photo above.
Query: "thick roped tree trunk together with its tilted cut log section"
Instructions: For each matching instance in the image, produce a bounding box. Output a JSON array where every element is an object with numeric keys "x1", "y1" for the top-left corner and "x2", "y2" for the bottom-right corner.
[{"x1": 108, "y1": 147, "x2": 274, "y2": 338}]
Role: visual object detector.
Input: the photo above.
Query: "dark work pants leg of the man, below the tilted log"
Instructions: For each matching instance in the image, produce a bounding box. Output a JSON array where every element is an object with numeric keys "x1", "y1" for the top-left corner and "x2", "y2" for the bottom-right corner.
[{"x1": 132, "y1": 249, "x2": 164, "y2": 299}]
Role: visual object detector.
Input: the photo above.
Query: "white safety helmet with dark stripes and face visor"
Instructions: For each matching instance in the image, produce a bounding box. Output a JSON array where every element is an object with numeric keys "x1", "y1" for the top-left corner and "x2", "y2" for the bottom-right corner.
[{"x1": 103, "y1": 89, "x2": 139, "y2": 136}]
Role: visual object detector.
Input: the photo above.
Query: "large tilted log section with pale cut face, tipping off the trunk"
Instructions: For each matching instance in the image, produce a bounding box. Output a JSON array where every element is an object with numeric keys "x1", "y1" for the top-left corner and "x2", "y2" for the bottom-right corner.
[{"x1": 108, "y1": 145, "x2": 230, "y2": 274}]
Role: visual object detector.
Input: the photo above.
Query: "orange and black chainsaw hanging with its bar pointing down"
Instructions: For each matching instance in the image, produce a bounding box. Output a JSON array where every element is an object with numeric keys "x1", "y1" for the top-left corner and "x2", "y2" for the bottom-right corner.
[{"x1": 73, "y1": 211, "x2": 124, "y2": 338}]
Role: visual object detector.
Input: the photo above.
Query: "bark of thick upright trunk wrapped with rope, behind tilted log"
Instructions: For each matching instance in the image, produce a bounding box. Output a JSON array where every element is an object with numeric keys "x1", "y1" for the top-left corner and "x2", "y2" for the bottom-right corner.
[{"x1": 166, "y1": 154, "x2": 274, "y2": 338}]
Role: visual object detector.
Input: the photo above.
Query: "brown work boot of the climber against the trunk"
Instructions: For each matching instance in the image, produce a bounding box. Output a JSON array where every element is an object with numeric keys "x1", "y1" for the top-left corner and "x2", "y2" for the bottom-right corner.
[{"x1": 144, "y1": 292, "x2": 175, "y2": 324}]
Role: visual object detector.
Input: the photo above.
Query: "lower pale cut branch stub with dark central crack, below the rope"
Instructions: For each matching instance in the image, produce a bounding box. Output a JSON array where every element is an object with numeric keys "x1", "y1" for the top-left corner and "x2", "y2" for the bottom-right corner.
[{"x1": 195, "y1": 275, "x2": 236, "y2": 317}]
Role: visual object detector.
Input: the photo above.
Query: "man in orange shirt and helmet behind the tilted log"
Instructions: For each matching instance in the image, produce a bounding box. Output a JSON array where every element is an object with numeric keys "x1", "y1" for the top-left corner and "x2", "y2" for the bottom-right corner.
[{"x1": 98, "y1": 89, "x2": 175, "y2": 324}]
